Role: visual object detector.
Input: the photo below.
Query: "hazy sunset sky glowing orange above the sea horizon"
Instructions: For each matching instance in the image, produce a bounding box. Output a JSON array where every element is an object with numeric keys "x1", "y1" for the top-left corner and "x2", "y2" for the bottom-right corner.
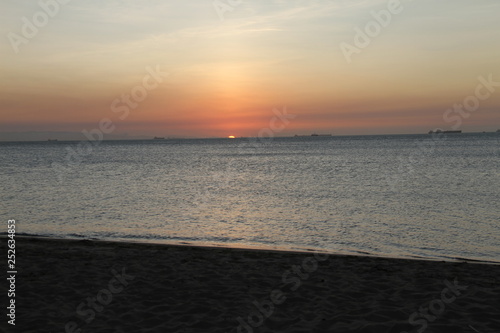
[{"x1": 0, "y1": 0, "x2": 500, "y2": 140}]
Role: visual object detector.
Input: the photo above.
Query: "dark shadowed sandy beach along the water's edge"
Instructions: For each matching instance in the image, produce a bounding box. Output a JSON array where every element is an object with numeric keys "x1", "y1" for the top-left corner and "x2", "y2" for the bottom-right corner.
[{"x1": 0, "y1": 236, "x2": 500, "y2": 333}]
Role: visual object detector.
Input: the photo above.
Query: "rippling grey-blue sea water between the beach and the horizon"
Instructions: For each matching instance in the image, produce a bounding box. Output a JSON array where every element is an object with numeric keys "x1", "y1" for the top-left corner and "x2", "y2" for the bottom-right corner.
[{"x1": 0, "y1": 133, "x2": 500, "y2": 262}]
